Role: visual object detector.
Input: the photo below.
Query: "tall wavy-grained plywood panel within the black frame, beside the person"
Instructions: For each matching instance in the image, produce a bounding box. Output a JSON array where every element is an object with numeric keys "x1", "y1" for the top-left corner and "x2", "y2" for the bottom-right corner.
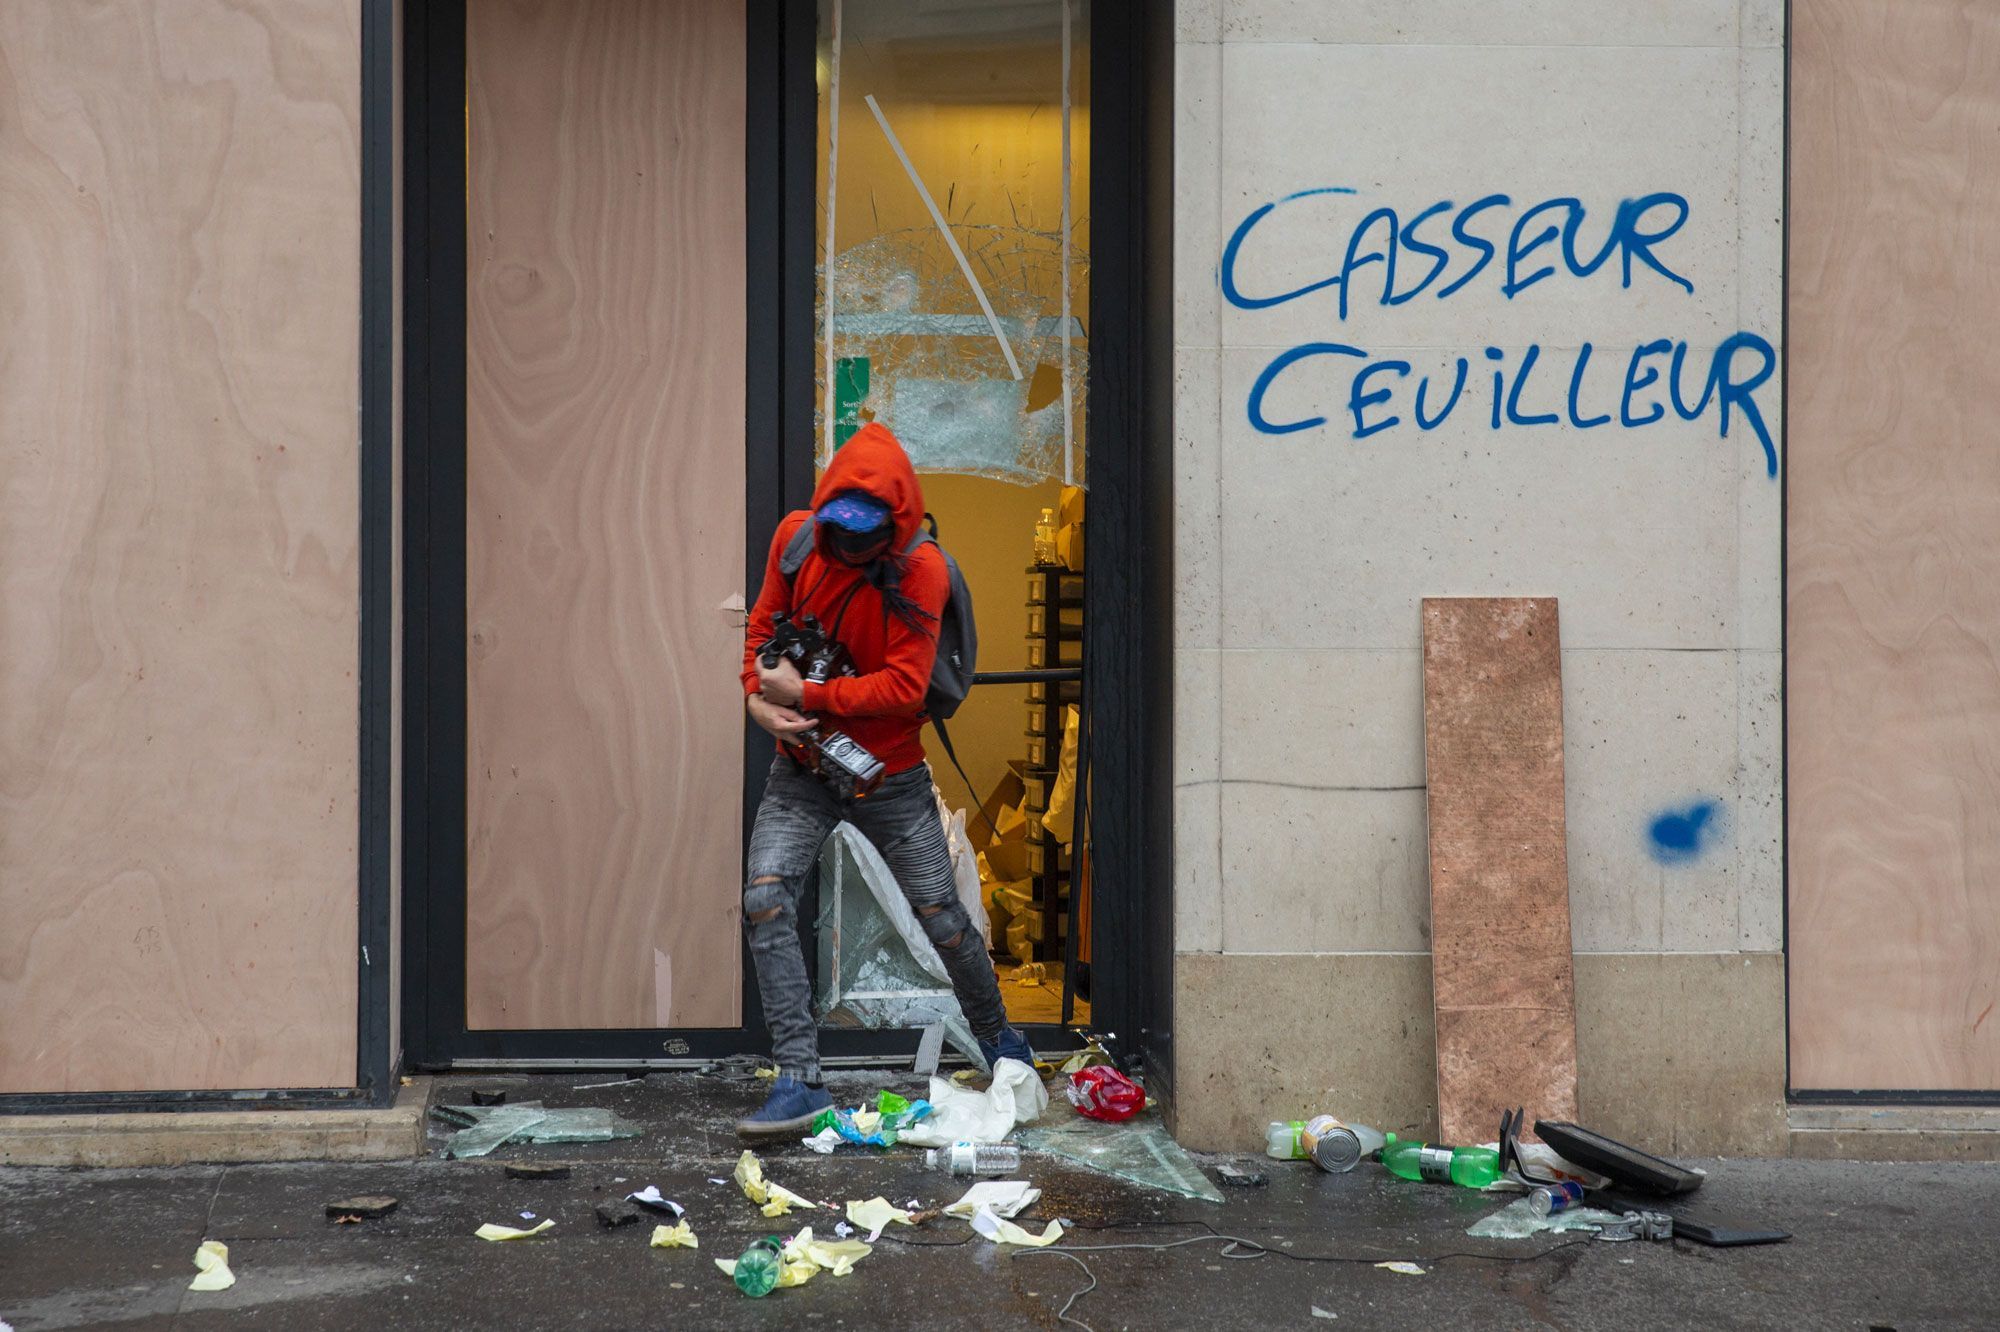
[{"x1": 466, "y1": 0, "x2": 754, "y2": 1028}]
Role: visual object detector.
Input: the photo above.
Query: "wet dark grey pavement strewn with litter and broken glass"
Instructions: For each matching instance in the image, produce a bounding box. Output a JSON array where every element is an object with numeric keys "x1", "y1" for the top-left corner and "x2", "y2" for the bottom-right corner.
[{"x1": 0, "y1": 1074, "x2": 2000, "y2": 1332}]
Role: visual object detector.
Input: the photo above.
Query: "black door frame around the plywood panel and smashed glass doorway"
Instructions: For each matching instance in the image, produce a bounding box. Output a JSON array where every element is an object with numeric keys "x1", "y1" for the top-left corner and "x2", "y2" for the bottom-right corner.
[{"x1": 402, "y1": 0, "x2": 1174, "y2": 1088}]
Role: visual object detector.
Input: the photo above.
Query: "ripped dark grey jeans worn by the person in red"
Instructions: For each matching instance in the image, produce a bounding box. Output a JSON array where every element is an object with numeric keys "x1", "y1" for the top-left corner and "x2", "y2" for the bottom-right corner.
[{"x1": 744, "y1": 754, "x2": 1006, "y2": 1082}]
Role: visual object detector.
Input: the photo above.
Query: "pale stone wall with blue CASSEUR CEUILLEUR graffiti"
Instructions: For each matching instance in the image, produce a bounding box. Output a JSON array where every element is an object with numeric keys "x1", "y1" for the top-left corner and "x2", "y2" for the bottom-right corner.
[{"x1": 1174, "y1": 0, "x2": 1784, "y2": 1152}]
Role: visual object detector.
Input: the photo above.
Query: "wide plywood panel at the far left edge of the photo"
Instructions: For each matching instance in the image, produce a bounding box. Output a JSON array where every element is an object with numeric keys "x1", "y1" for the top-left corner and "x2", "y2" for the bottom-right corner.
[{"x1": 0, "y1": 0, "x2": 360, "y2": 1092}]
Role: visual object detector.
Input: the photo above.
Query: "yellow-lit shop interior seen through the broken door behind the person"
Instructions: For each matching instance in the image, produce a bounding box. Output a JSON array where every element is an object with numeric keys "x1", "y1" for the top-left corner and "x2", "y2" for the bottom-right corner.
[{"x1": 816, "y1": 0, "x2": 1090, "y2": 1024}]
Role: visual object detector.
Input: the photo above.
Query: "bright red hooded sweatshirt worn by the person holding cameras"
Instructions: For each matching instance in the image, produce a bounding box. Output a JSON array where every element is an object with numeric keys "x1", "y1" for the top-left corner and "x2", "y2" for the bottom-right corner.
[{"x1": 742, "y1": 422, "x2": 950, "y2": 774}]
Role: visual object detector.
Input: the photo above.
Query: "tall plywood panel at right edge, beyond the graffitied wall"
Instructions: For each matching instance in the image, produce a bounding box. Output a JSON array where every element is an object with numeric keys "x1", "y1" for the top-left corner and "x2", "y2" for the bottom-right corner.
[{"x1": 1786, "y1": 0, "x2": 2000, "y2": 1090}]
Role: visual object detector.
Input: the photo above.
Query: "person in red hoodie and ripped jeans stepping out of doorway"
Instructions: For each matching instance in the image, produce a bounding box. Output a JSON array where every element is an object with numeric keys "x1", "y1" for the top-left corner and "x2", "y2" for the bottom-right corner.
[{"x1": 736, "y1": 424, "x2": 1034, "y2": 1138}]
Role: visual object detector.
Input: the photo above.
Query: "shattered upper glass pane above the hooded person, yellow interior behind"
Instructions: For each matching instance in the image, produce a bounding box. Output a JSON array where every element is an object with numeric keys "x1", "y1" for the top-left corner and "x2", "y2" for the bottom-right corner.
[{"x1": 816, "y1": 0, "x2": 1090, "y2": 484}]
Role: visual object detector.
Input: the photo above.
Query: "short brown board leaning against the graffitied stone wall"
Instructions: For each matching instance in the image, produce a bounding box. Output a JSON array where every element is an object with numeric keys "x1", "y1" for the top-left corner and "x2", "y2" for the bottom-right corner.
[{"x1": 1424, "y1": 598, "x2": 1576, "y2": 1144}]
